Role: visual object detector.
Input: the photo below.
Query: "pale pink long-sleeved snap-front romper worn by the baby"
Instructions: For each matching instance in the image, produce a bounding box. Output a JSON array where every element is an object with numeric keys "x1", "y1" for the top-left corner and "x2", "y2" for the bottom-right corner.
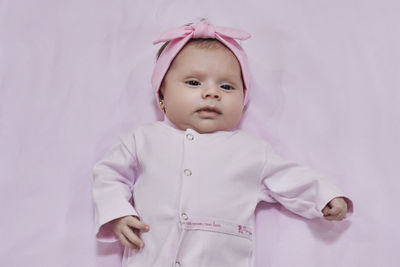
[{"x1": 93, "y1": 120, "x2": 344, "y2": 267}]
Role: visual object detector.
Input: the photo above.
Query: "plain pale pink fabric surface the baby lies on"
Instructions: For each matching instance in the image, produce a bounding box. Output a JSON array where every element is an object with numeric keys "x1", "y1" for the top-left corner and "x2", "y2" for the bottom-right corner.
[{"x1": 0, "y1": 0, "x2": 400, "y2": 267}]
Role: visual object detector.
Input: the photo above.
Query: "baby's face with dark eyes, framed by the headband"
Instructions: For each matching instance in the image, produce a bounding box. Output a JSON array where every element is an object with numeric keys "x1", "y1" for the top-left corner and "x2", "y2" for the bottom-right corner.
[{"x1": 160, "y1": 44, "x2": 244, "y2": 133}]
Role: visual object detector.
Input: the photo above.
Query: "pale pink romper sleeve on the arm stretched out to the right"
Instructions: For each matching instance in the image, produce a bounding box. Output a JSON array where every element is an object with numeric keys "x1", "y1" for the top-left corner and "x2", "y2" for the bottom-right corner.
[{"x1": 262, "y1": 144, "x2": 353, "y2": 219}]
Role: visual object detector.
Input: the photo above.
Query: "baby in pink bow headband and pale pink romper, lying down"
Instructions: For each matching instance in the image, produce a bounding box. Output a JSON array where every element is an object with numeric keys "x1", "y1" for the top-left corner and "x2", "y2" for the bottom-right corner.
[{"x1": 93, "y1": 20, "x2": 351, "y2": 267}]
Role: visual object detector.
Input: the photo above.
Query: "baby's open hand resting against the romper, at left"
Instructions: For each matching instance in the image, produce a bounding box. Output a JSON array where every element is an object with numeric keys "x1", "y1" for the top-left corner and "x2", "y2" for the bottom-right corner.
[{"x1": 110, "y1": 216, "x2": 150, "y2": 249}]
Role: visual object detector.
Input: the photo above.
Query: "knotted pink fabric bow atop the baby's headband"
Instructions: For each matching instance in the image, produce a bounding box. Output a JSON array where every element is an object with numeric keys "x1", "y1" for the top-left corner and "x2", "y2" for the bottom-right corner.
[{"x1": 153, "y1": 21, "x2": 251, "y2": 44}]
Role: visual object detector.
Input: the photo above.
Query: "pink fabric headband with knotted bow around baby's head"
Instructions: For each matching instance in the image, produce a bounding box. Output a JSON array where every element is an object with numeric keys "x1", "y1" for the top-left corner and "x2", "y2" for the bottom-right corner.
[{"x1": 151, "y1": 21, "x2": 250, "y2": 105}]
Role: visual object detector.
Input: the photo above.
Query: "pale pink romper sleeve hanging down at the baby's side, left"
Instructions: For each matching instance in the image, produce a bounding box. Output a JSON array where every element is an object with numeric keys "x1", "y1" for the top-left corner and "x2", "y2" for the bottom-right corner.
[{"x1": 92, "y1": 134, "x2": 139, "y2": 242}]
